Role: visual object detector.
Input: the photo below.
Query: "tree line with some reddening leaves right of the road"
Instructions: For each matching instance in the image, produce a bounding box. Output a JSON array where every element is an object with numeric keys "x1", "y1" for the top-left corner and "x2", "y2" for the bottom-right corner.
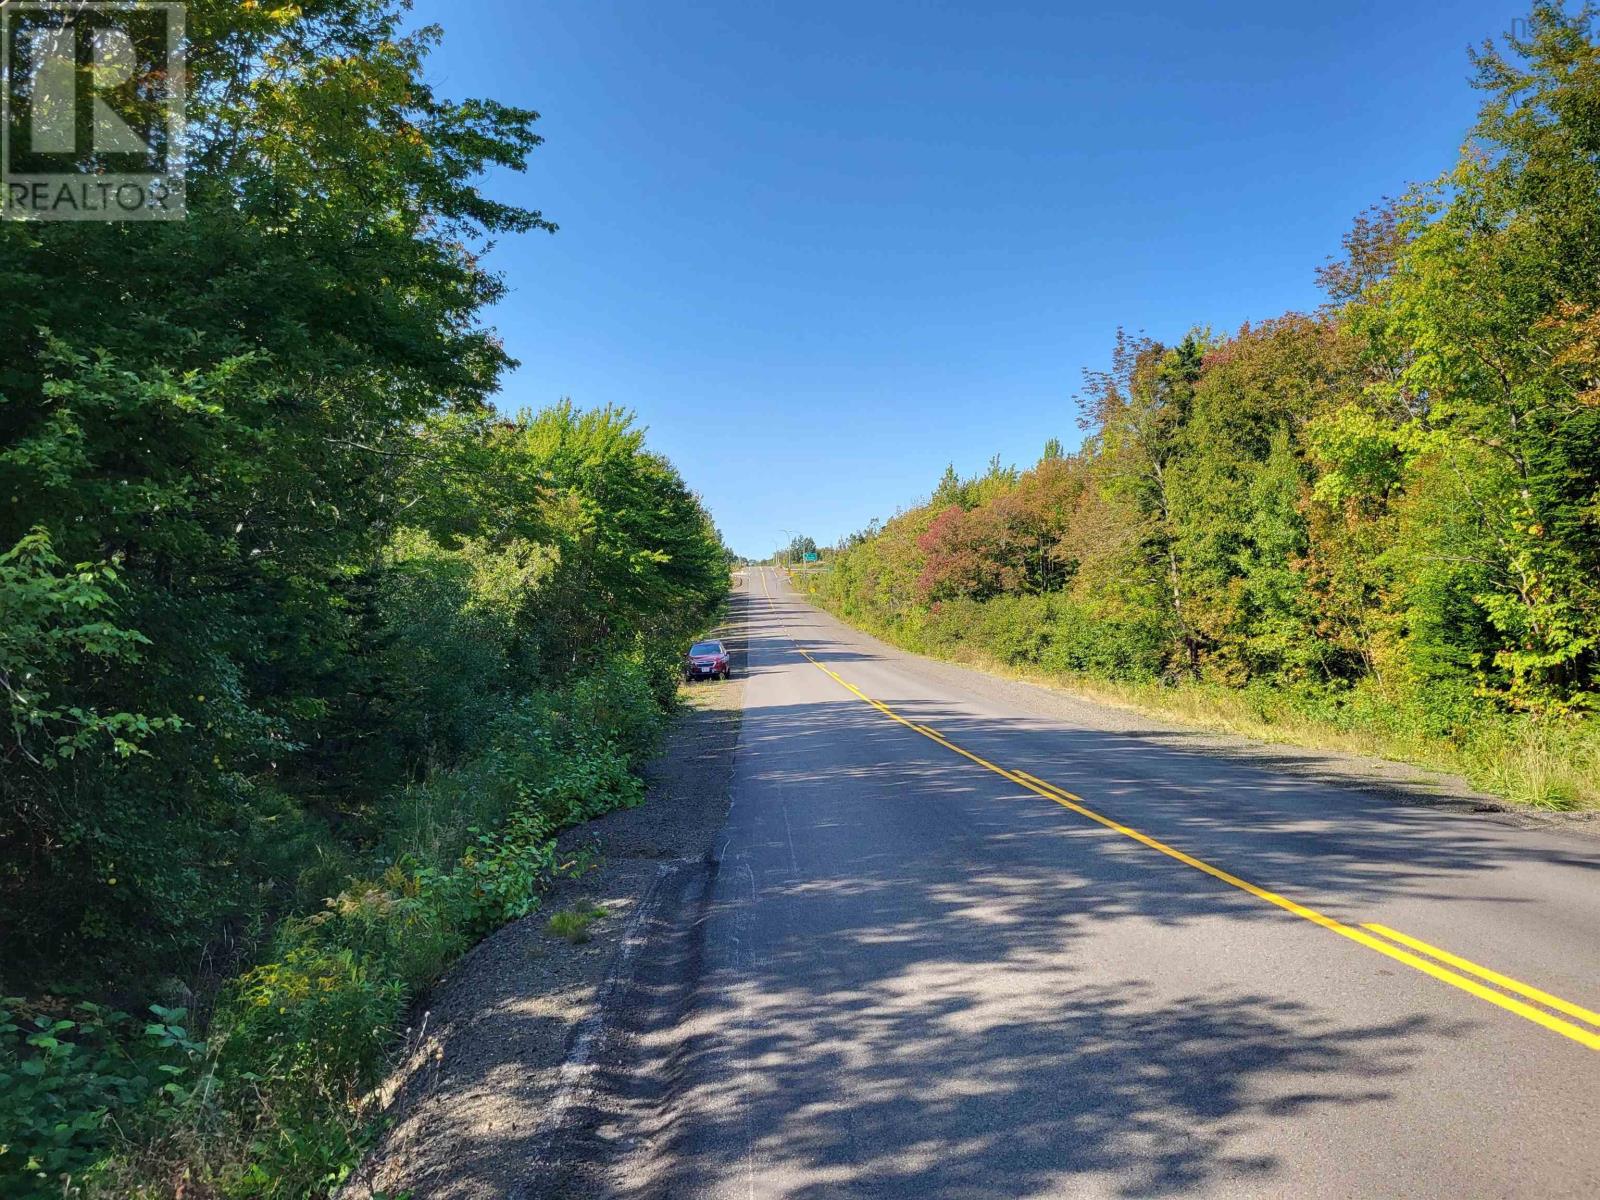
[{"x1": 813, "y1": 3, "x2": 1600, "y2": 803}]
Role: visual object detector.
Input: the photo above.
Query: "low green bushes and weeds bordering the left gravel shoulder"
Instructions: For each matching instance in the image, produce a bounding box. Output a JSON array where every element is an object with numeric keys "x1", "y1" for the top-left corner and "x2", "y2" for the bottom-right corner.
[{"x1": 0, "y1": 656, "x2": 700, "y2": 1200}]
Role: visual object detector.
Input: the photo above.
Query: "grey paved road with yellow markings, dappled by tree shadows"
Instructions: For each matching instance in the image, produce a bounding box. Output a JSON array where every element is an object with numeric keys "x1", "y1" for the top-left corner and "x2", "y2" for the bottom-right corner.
[{"x1": 617, "y1": 571, "x2": 1600, "y2": 1200}]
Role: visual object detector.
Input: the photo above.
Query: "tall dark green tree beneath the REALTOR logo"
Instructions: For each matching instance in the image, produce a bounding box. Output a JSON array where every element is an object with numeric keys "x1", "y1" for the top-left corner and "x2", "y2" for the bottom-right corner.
[{"x1": 0, "y1": 0, "x2": 549, "y2": 978}]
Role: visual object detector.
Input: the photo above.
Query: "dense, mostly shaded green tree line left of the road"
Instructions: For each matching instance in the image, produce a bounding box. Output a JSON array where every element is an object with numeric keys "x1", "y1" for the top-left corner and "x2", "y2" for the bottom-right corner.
[{"x1": 0, "y1": 0, "x2": 728, "y2": 1197}]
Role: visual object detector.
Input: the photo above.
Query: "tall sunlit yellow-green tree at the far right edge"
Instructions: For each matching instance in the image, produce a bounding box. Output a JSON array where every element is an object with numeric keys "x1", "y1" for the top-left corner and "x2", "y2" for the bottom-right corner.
[{"x1": 1357, "y1": 3, "x2": 1600, "y2": 710}]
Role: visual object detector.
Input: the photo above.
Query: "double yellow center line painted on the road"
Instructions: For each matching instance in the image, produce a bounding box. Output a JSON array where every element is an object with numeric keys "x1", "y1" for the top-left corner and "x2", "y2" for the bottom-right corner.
[{"x1": 762, "y1": 571, "x2": 1600, "y2": 1050}]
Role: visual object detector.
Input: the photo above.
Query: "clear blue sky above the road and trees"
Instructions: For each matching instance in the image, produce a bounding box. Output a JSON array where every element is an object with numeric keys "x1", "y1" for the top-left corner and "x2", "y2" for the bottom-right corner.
[{"x1": 416, "y1": 0, "x2": 1525, "y2": 554}]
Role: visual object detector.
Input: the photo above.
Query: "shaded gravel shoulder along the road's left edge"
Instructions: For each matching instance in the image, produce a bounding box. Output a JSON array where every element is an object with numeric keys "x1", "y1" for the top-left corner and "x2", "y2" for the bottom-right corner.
[{"x1": 344, "y1": 597, "x2": 746, "y2": 1200}]
